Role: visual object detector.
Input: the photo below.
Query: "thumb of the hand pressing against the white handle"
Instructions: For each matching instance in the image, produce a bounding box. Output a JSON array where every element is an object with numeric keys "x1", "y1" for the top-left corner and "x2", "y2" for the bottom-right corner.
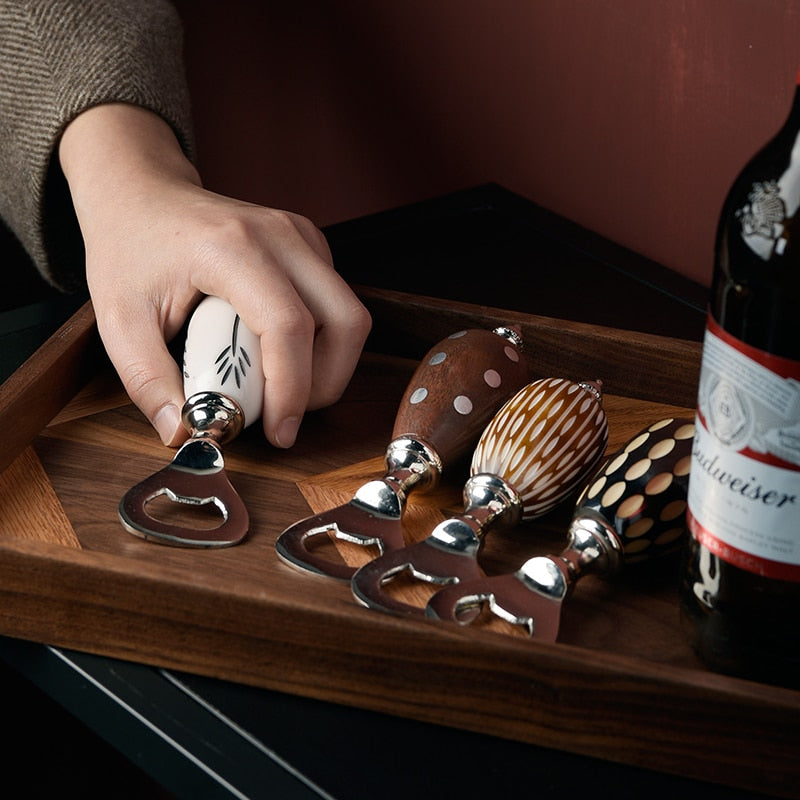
[{"x1": 97, "y1": 310, "x2": 187, "y2": 447}]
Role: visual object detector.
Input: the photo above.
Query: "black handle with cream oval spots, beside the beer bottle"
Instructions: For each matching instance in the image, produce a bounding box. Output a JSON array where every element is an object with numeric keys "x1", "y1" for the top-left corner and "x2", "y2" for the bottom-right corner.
[{"x1": 570, "y1": 417, "x2": 694, "y2": 573}]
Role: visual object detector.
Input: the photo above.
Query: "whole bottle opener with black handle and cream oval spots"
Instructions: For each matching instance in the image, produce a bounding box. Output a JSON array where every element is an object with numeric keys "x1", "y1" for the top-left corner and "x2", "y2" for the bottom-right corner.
[{"x1": 426, "y1": 419, "x2": 694, "y2": 642}]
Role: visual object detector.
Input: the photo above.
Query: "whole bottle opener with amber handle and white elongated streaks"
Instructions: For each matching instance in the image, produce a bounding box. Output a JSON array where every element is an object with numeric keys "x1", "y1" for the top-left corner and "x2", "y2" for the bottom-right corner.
[{"x1": 351, "y1": 378, "x2": 608, "y2": 615}]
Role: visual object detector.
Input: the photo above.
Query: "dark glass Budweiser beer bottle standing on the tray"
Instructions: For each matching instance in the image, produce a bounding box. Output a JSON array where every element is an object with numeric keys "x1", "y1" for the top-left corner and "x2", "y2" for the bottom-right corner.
[{"x1": 680, "y1": 67, "x2": 800, "y2": 687}]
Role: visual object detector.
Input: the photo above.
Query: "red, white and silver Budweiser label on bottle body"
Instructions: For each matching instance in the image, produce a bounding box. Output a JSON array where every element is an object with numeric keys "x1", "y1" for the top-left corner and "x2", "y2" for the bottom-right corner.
[{"x1": 688, "y1": 316, "x2": 800, "y2": 581}]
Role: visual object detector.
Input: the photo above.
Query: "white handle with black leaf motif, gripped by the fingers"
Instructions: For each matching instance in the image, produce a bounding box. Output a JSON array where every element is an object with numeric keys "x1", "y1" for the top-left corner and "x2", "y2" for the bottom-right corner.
[{"x1": 183, "y1": 296, "x2": 264, "y2": 426}]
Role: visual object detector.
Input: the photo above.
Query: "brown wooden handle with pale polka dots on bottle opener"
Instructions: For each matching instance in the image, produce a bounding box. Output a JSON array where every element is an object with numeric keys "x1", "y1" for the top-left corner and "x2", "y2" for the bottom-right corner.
[{"x1": 392, "y1": 328, "x2": 530, "y2": 465}]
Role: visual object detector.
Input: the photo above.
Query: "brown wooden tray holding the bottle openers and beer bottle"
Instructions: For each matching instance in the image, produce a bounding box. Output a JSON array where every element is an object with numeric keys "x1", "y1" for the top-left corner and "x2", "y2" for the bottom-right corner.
[{"x1": 0, "y1": 289, "x2": 800, "y2": 797}]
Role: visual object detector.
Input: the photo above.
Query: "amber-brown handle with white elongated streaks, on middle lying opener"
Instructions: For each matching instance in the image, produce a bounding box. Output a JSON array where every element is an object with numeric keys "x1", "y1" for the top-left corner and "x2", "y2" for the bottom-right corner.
[{"x1": 470, "y1": 378, "x2": 608, "y2": 520}]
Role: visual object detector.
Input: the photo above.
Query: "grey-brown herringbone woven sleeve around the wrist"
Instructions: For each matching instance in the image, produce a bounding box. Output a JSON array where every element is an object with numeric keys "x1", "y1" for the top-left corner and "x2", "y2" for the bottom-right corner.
[{"x1": 0, "y1": 0, "x2": 193, "y2": 291}]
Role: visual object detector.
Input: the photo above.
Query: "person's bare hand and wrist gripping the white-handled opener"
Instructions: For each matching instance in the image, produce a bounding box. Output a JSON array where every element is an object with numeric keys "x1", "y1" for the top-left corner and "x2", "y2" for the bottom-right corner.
[{"x1": 59, "y1": 104, "x2": 371, "y2": 447}]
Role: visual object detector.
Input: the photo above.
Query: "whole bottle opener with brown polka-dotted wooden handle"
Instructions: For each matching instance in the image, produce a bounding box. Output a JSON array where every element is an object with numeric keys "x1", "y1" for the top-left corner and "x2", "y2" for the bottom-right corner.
[{"x1": 275, "y1": 327, "x2": 529, "y2": 581}]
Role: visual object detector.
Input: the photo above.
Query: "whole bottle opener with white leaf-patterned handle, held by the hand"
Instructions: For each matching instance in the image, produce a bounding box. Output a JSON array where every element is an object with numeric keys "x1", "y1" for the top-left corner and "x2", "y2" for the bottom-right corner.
[{"x1": 119, "y1": 297, "x2": 264, "y2": 547}]
